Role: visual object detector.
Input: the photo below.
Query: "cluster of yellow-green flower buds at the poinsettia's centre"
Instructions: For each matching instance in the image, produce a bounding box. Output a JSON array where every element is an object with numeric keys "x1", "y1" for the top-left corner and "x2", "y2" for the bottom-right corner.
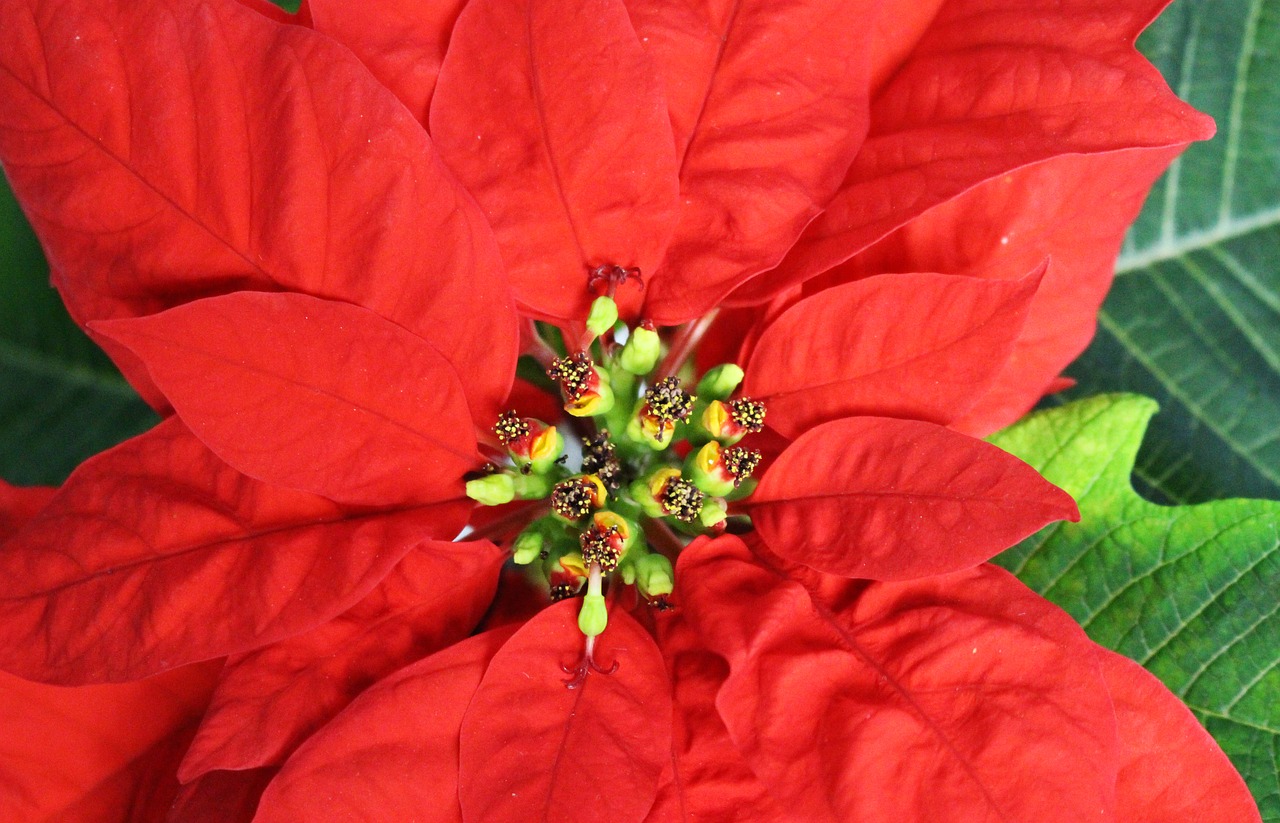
[{"x1": 467, "y1": 297, "x2": 764, "y2": 647}]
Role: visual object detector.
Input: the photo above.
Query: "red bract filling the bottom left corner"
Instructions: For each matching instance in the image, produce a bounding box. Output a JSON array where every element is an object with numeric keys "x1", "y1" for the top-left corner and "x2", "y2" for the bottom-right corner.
[{"x1": 0, "y1": 663, "x2": 219, "y2": 823}]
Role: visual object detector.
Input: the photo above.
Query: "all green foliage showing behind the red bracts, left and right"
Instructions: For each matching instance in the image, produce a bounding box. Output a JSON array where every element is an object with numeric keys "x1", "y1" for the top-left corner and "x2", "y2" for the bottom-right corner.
[{"x1": 0, "y1": 0, "x2": 1280, "y2": 822}]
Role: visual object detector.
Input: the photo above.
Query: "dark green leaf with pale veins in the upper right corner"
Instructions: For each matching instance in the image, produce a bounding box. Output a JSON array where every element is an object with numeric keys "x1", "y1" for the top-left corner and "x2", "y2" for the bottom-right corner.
[{"x1": 1068, "y1": 0, "x2": 1280, "y2": 502}]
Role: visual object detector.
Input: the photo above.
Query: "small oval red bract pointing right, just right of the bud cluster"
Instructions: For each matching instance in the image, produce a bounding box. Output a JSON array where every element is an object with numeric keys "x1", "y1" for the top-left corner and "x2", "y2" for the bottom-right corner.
[{"x1": 748, "y1": 417, "x2": 1079, "y2": 580}]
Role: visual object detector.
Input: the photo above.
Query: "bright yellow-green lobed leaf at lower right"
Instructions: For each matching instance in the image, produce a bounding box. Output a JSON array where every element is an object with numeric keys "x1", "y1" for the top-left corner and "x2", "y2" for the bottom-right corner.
[{"x1": 992, "y1": 394, "x2": 1280, "y2": 820}]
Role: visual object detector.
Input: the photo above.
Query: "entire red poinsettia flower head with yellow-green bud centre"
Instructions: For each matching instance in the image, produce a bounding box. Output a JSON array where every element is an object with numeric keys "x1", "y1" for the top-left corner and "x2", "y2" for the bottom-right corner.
[{"x1": 0, "y1": 0, "x2": 1257, "y2": 822}]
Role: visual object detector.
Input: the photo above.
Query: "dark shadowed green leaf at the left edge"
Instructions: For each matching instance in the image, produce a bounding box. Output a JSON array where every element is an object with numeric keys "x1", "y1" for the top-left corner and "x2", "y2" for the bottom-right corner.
[{"x1": 0, "y1": 178, "x2": 157, "y2": 485}]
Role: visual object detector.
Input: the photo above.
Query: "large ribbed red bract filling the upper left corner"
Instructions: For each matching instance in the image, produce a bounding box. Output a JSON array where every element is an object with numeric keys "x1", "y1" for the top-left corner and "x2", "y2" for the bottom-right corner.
[{"x1": 0, "y1": 0, "x2": 516, "y2": 417}]
